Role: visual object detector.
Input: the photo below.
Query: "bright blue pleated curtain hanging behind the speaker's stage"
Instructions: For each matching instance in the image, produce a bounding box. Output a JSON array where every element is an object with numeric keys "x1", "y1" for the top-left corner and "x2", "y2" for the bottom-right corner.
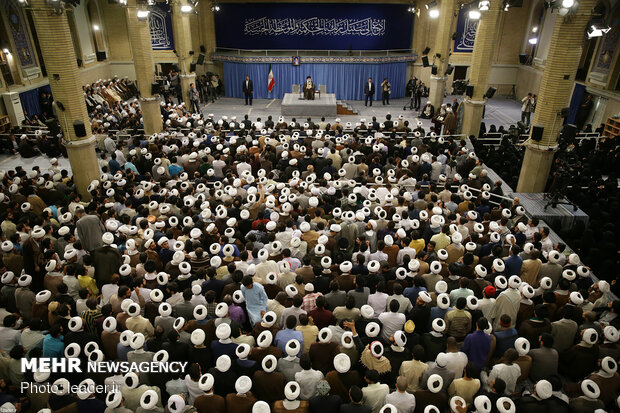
[{"x1": 224, "y1": 62, "x2": 407, "y2": 100}]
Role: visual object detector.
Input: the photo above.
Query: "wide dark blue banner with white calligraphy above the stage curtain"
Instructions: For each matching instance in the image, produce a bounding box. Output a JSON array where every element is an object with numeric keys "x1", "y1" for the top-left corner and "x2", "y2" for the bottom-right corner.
[{"x1": 215, "y1": 3, "x2": 413, "y2": 50}]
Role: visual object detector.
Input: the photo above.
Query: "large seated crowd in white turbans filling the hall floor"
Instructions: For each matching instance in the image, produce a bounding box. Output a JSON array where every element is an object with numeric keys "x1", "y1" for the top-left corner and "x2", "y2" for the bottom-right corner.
[{"x1": 0, "y1": 91, "x2": 620, "y2": 413}]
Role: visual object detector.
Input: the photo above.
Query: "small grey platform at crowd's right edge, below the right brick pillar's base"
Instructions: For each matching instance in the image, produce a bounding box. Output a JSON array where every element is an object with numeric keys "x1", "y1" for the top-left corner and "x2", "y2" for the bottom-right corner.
[{"x1": 510, "y1": 192, "x2": 589, "y2": 230}]
